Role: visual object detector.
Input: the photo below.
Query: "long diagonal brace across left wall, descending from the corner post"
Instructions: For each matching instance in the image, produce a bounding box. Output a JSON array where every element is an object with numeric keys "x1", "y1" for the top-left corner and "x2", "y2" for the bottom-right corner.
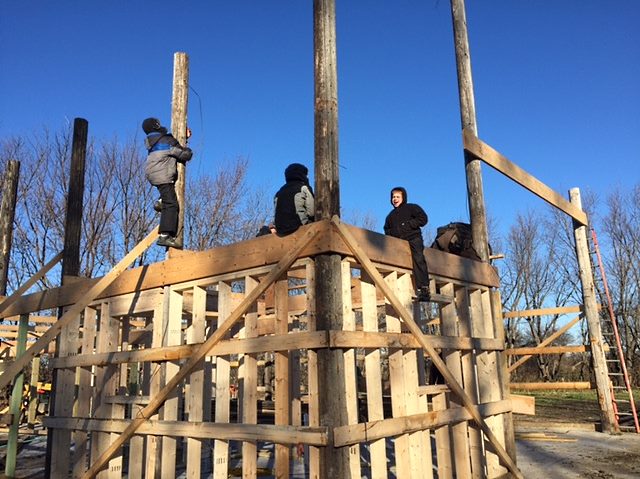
[{"x1": 82, "y1": 225, "x2": 318, "y2": 479}]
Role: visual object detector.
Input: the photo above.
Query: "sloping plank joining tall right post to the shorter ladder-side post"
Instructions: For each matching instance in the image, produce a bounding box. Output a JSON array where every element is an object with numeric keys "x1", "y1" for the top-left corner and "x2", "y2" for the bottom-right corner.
[{"x1": 462, "y1": 128, "x2": 589, "y2": 226}]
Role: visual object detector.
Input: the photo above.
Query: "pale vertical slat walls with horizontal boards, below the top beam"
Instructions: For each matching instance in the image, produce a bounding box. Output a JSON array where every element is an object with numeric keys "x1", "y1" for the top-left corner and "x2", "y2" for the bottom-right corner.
[{"x1": 37, "y1": 259, "x2": 510, "y2": 479}]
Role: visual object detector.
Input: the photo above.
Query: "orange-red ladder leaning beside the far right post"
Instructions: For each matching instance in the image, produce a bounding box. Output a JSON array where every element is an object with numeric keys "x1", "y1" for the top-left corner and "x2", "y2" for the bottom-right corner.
[{"x1": 591, "y1": 228, "x2": 640, "y2": 433}]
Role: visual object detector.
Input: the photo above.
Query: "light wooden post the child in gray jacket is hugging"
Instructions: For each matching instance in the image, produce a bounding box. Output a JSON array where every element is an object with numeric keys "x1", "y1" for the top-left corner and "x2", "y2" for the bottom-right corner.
[{"x1": 171, "y1": 52, "x2": 189, "y2": 248}]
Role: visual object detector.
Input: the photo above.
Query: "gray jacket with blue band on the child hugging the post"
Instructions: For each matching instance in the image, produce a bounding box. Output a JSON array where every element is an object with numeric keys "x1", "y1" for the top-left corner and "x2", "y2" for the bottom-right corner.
[{"x1": 144, "y1": 127, "x2": 193, "y2": 186}]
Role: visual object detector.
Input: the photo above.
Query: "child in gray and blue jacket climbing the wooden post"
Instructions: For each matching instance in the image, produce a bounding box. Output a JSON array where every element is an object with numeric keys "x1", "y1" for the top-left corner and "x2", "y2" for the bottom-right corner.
[{"x1": 142, "y1": 118, "x2": 193, "y2": 249}]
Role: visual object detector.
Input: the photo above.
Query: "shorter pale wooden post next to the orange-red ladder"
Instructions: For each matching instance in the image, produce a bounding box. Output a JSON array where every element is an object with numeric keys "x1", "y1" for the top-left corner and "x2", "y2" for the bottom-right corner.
[{"x1": 569, "y1": 188, "x2": 619, "y2": 434}]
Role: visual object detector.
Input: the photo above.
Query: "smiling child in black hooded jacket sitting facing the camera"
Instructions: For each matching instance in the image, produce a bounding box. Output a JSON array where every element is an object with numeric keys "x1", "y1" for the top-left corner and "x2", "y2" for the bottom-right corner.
[{"x1": 384, "y1": 186, "x2": 431, "y2": 301}]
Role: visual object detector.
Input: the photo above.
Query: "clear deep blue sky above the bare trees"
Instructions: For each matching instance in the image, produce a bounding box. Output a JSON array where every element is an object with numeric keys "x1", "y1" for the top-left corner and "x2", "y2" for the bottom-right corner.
[{"x1": 0, "y1": 0, "x2": 640, "y2": 238}]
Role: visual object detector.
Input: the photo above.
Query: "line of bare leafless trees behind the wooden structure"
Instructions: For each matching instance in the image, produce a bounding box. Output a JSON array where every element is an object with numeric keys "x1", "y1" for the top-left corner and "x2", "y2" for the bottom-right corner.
[{"x1": 0, "y1": 129, "x2": 640, "y2": 384}]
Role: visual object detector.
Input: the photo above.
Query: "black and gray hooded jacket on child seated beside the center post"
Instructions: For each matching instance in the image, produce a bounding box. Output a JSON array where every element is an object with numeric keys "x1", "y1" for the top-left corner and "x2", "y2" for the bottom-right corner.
[{"x1": 274, "y1": 163, "x2": 315, "y2": 236}]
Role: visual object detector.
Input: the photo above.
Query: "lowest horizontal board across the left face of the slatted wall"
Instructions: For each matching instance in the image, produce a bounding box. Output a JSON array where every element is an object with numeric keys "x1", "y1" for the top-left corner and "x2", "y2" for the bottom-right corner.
[{"x1": 42, "y1": 417, "x2": 329, "y2": 446}]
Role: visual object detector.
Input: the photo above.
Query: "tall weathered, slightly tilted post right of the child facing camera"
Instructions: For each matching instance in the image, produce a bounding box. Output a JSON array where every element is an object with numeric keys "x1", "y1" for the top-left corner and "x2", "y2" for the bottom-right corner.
[{"x1": 451, "y1": 0, "x2": 489, "y2": 261}]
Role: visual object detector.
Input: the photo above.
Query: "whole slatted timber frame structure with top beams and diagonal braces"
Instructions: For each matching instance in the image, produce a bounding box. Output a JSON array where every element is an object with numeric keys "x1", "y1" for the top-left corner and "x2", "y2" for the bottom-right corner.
[{"x1": 0, "y1": 217, "x2": 521, "y2": 478}]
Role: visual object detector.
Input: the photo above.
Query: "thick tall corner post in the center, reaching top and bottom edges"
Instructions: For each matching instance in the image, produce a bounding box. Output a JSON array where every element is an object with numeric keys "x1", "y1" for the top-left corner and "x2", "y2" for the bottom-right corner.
[{"x1": 313, "y1": 0, "x2": 350, "y2": 478}]
